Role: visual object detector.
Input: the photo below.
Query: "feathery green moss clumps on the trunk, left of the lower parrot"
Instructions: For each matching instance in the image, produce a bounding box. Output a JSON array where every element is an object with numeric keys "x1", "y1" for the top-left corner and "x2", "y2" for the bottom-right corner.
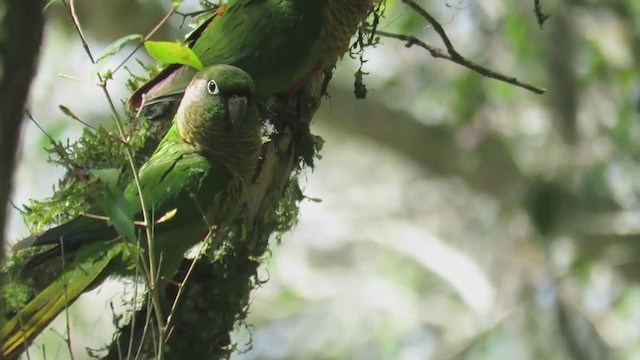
[{"x1": 0, "y1": 113, "x2": 159, "y2": 326}]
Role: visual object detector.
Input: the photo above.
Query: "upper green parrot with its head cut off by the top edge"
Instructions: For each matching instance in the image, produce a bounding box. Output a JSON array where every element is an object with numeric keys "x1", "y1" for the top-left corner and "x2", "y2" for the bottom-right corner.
[{"x1": 128, "y1": 0, "x2": 374, "y2": 109}]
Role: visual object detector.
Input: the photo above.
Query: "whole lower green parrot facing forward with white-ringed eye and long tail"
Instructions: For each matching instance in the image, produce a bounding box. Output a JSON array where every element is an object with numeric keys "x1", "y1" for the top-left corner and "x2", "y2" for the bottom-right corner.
[{"x1": 0, "y1": 65, "x2": 262, "y2": 357}]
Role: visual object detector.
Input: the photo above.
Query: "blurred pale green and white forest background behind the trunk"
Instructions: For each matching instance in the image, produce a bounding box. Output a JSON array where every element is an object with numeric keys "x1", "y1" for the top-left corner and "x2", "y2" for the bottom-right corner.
[{"x1": 9, "y1": 0, "x2": 640, "y2": 360}]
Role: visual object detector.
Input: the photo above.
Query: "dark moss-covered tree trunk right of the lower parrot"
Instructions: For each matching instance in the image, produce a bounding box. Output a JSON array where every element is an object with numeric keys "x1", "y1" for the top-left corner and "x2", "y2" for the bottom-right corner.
[{"x1": 105, "y1": 59, "x2": 340, "y2": 359}]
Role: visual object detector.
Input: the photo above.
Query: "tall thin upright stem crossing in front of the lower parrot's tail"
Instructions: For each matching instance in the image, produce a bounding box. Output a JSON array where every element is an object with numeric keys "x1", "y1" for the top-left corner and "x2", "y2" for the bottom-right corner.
[{"x1": 62, "y1": 0, "x2": 165, "y2": 354}]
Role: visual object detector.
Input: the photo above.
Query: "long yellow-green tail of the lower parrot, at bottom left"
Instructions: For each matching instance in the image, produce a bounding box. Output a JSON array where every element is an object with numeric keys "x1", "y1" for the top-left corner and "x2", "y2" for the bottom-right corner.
[{"x1": 0, "y1": 242, "x2": 127, "y2": 357}]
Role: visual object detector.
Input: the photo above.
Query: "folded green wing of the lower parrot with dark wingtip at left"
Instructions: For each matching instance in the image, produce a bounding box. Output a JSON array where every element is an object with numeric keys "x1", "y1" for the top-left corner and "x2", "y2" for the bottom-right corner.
[{"x1": 15, "y1": 126, "x2": 231, "y2": 249}]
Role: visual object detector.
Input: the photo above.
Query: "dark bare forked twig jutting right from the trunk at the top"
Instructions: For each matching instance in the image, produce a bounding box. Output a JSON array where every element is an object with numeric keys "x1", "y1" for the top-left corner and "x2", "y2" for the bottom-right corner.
[{"x1": 376, "y1": 0, "x2": 546, "y2": 94}]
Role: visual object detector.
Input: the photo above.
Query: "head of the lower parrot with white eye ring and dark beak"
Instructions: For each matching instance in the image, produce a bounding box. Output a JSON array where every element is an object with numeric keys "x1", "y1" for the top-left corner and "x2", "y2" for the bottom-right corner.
[{"x1": 176, "y1": 65, "x2": 259, "y2": 144}]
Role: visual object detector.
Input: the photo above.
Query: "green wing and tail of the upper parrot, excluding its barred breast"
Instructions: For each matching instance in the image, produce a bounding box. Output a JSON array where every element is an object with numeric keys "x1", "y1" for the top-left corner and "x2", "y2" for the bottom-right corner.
[{"x1": 129, "y1": 0, "x2": 327, "y2": 108}]
